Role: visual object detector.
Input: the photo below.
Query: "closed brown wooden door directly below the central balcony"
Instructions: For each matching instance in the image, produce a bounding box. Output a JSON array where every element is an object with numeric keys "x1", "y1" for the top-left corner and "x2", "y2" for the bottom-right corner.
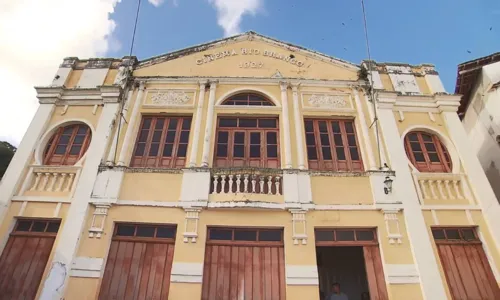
[{"x1": 201, "y1": 228, "x2": 285, "y2": 300}]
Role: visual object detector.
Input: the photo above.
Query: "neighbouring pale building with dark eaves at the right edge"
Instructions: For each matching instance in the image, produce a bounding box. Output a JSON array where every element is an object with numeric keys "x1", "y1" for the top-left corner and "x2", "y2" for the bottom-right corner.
[{"x1": 455, "y1": 53, "x2": 500, "y2": 204}]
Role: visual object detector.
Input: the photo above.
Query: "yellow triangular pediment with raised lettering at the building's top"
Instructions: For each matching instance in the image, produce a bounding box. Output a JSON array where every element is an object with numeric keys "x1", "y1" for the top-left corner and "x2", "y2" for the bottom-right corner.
[{"x1": 134, "y1": 31, "x2": 359, "y2": 80}]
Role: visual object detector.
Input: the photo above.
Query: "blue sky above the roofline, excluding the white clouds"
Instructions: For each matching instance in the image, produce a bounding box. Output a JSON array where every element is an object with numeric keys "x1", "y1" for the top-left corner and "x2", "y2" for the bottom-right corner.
[{"x1": 107, "y1": 0, "x2": 500, "y2": 92}]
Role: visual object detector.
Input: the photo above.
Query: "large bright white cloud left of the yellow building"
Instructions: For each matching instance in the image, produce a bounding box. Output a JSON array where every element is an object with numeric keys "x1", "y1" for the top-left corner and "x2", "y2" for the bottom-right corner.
[{"x1": 0, "y1": 0, "x2": 120, "y2": 145}]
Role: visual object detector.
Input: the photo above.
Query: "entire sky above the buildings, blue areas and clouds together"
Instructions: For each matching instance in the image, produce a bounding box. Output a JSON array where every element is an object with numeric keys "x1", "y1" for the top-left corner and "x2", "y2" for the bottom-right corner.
[{"x1": 0, "y1": 0, "x2": 500, "y2": 145}]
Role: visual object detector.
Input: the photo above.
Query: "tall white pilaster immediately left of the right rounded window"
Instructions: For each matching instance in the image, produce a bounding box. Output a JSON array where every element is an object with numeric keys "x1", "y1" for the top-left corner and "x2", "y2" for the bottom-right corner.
[{"x1": 378, "y1": 98, "x2": 446, "y2": 299}]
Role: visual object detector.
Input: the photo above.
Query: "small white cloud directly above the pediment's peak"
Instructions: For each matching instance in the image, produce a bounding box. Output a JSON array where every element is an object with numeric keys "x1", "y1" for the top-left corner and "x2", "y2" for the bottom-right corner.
[{"x1": 208, "y1": 0, "x2": 263, "y2": 36}]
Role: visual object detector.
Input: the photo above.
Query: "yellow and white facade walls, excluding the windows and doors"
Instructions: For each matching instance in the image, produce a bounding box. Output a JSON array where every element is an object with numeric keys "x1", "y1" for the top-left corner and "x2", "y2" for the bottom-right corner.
[{"x1": 0, "y1": 32, "x2": 500, "y2": 300}]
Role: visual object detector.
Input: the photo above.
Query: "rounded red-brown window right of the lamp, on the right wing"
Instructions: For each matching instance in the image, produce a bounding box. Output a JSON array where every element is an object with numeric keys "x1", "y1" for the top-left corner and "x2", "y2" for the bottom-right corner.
[{"x1": 405, "y1": 131, "x2": 451, "y2": 173}]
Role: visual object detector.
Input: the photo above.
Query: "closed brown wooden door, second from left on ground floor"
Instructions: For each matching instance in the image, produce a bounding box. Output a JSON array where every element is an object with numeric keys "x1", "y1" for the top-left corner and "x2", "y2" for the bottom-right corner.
[{"x1": 99, "y1": 224, "x2": 175, "y2": 300}]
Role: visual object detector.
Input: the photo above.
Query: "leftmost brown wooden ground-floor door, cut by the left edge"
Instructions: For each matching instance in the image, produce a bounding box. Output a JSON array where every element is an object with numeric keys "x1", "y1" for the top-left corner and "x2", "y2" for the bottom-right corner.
[{"x1": 0, "y1": 219, "x2": 60, "y2": 300}]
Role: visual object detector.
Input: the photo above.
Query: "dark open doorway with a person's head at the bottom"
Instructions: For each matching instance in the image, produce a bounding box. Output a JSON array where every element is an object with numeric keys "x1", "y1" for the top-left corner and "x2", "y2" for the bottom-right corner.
[{"x1": 316, "y1": 246, "x2": 369, "y2": 300}]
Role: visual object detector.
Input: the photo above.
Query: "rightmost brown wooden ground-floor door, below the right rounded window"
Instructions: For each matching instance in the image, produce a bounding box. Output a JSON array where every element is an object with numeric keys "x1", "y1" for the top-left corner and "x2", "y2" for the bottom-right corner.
[{"x1": 432, "y1": 228, "x2": 500, "y2": 300}]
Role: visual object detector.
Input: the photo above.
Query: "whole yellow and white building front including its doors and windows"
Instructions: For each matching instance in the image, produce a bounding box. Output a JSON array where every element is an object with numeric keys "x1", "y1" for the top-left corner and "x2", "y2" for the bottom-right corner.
[{"x1": 0, "y1": 32, "x2": 500, "y2": 300}]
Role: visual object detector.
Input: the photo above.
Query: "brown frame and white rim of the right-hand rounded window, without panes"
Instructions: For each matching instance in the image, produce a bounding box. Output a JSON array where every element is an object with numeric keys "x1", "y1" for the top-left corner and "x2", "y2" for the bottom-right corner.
[{"x1": 403, "y1": 129, "x2": 456, "y2": 173}]
